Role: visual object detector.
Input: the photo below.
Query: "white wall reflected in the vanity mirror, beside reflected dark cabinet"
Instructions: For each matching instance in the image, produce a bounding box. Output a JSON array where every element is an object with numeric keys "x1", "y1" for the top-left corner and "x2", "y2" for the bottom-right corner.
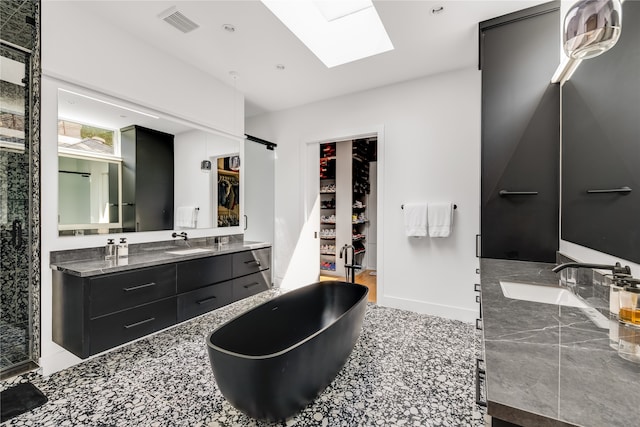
[{"x1": 173, "y1": 130, "x2": 243, "y2": 228}]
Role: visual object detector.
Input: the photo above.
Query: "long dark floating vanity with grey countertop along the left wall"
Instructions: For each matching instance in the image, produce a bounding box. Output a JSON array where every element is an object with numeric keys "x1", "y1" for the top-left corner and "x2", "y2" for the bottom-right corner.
[{"x1": 51, "y1": 242, "x2": 272, "y2": 358}]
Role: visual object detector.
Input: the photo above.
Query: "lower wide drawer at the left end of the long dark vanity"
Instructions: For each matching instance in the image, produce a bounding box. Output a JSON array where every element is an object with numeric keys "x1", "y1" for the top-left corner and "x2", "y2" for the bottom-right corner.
[{"x1": 89, "y1": 297, "x2": 176, "y2": 354}]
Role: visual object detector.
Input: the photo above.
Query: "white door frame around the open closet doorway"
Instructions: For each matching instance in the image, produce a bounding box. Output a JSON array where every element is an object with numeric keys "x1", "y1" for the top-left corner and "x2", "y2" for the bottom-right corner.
[{"x1": 300, "y1": 125, "x2": 385, "y2": 305}]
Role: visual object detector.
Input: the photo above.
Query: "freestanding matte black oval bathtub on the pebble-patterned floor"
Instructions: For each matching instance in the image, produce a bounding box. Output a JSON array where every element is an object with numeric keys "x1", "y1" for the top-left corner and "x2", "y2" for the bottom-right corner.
[{"x1": 207, "y1": 281, "x2": 369, "y2": 421}]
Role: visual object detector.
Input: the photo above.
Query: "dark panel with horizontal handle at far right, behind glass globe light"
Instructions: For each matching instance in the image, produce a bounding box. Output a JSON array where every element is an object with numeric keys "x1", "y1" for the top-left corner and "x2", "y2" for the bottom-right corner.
[{"x1": 562, "y1": 1, "x2": 640, "y2": 263}]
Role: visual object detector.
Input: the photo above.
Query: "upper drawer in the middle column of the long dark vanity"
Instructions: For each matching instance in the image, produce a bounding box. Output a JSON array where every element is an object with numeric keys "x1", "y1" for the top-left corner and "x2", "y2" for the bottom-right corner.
[{"x1": 178, "y1": 255, "x2": 233, "y2": 293}]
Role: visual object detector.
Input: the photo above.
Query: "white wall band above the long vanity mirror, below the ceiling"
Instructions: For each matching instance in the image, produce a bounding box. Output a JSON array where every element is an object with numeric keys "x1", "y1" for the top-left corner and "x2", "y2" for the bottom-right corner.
[{"x1": 42, "y1": 1, "x2": 244, "y2": 136}]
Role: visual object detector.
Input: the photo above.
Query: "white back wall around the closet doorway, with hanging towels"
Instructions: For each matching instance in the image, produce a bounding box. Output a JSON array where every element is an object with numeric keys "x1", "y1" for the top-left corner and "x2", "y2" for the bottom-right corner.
[{"x1": 246, "y1": 69, "x2": 480, "y2": 321}]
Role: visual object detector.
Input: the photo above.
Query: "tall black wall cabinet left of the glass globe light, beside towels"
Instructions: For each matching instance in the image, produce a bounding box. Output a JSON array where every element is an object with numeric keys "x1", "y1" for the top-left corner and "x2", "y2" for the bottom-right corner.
[{"x1": 480, "y1": 2, "x2": 560, "y2": 262}]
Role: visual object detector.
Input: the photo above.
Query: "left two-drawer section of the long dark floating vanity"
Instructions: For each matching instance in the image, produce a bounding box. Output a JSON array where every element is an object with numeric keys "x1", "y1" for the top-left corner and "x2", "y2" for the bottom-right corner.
[{"x1": 53, "y1": 265, "x2": 176, "y2": 358}]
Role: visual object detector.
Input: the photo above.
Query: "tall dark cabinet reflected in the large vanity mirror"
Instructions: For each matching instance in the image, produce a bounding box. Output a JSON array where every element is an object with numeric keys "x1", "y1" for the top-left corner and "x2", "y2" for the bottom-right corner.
[{"x1": 120, "y1": 126, "x2": 174, "y2": 232}]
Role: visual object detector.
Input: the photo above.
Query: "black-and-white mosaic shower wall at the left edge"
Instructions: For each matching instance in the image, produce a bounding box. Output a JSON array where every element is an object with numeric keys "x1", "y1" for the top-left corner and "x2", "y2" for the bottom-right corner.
[{"x1": 0, "y1": 0, "x2": 41, "y2": 366}]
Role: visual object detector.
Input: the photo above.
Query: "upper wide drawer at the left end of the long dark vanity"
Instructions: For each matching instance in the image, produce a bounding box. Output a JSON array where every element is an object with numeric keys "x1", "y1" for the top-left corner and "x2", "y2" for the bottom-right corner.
[{"x1": 89, "y1": 265, "x2": 176, "y2": 318}]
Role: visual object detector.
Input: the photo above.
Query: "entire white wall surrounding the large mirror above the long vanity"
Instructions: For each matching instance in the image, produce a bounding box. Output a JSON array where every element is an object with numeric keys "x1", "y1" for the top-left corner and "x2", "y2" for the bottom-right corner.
[{"x1": 40, "y1": 1, "x2": 244, "y2": 375}]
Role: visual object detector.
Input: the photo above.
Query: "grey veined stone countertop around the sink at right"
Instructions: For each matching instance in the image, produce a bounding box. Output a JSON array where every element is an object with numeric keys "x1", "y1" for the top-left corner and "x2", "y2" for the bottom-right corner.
[{"x1": 481, "y1": 259, "x2": 640, "y2": 427}]
